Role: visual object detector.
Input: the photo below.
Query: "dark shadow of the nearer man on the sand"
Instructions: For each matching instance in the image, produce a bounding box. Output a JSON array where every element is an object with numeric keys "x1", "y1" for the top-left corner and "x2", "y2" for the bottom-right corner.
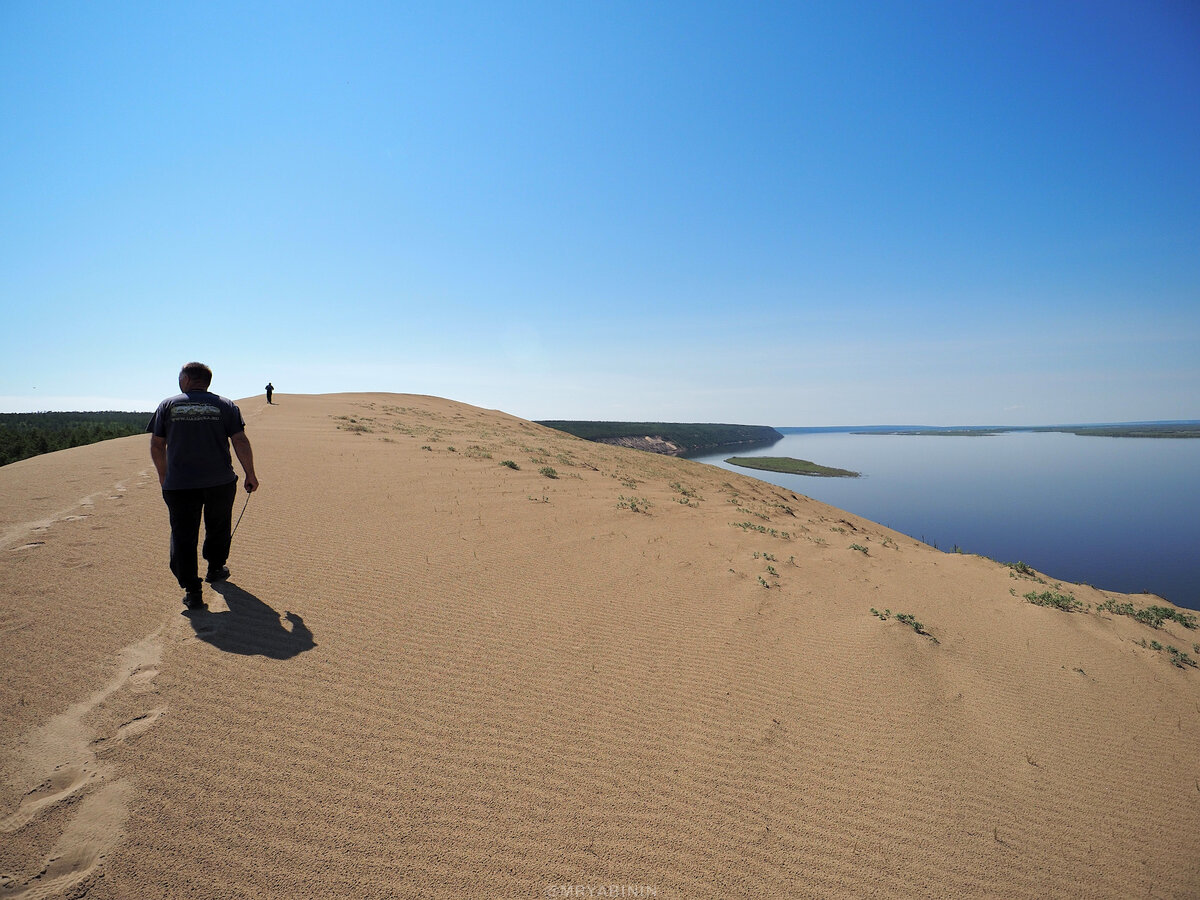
[{"x1": 184, "y1": 581, "x2": 317, "y2": 659}]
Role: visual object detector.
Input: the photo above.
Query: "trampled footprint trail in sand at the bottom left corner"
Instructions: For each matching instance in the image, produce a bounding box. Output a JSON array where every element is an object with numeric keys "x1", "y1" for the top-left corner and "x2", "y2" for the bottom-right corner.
[{"x1": 0, "y1": 629, "x2": 167, "y2": 900}]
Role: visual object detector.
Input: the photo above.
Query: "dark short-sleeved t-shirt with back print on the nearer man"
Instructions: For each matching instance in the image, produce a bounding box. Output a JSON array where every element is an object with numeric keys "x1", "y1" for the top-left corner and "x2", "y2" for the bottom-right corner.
[{"x1": 146, "y1": 391, "x2": 246, "y2": 491}]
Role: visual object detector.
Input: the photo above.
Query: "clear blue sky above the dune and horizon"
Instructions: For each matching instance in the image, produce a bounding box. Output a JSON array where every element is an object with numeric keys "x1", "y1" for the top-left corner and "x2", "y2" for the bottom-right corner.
[{"x1": 0, "y1": 0, "x2": 1200, "y2": 425}]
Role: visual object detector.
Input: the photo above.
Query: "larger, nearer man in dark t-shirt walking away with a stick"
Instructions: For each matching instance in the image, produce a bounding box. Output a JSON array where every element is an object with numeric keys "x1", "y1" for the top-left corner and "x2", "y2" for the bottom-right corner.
[{"x1": 146, "y1": 362, "x2": 258, "y2": 610}]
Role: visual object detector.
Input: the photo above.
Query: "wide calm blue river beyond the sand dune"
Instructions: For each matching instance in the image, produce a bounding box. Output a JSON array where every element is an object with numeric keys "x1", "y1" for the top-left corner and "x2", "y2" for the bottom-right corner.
[{"x1": 692, "y1": 432, "x2": 1200, "y2": 610}]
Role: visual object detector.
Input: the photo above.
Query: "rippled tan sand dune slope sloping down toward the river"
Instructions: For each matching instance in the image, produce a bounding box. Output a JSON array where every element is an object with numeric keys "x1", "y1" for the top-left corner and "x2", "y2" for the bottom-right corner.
[{"x1": 0, "y1": 395, "x2": 1200, "y2": 899}]
